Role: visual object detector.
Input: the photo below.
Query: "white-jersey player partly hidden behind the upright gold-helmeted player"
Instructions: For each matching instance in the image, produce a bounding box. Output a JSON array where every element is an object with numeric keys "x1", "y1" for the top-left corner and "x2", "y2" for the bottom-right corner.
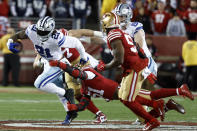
[{"x1": 114, "y1": 4, "x2": 157, "y2": 80}]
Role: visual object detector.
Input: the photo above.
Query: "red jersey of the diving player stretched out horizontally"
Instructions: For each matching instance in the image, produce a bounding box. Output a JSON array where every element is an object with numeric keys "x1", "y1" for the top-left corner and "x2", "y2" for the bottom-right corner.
[{"x1": 81, "y1": 67, "x2": 118, "y2": 100}]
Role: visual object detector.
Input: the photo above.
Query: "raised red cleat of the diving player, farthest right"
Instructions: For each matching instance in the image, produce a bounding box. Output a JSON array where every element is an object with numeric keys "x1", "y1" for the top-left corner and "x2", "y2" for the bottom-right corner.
[{"x1": 179, "y1": 84, "x2": 194, "y2": 100}]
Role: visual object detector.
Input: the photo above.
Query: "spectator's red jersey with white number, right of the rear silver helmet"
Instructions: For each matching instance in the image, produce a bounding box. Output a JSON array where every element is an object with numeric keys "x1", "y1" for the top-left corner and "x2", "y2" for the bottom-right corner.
[{"x1": 151, "y1": 10, "x2": 170, "y2": 33}]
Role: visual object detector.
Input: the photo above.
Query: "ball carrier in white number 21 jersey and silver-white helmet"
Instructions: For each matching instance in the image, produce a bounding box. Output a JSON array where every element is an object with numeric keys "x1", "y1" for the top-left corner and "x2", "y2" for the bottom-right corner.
[{"x1": 7, "y1": 16, "x2": 88, "y2": 124}]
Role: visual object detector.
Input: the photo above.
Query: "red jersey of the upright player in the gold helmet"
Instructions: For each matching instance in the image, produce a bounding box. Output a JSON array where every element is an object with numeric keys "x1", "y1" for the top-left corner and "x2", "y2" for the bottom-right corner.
[{"x1": 107, "y1": 29, "x2": 148, "y2": 73}]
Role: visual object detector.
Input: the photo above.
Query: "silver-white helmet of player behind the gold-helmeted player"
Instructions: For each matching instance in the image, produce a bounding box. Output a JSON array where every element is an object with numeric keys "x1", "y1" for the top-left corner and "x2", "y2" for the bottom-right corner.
[{"x1": 114, "y1": 4, "x2": 133, "y2": 26}]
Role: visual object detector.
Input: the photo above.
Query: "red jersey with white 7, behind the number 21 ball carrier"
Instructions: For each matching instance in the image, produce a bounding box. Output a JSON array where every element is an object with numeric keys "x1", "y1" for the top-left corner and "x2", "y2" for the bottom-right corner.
[{"x1": 59, "y1": 28, "x2": 80, "y2": 63}]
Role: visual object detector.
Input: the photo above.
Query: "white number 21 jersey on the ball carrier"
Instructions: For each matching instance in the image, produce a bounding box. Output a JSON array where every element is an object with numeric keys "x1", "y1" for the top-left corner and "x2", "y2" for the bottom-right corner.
[{"x1": 25, "y1": 24, "x2": 87, "y2": 60}]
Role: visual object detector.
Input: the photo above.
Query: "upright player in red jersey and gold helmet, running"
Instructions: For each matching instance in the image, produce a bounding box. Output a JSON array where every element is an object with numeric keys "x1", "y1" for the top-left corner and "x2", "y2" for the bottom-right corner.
[{"x1": 97, "y1": 13, "x2": 193, "y2": 130}]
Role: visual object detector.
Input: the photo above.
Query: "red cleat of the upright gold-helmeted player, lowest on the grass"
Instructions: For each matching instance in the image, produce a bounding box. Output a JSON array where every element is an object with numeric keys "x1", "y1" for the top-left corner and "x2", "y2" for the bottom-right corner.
[{"x1": 142, "y1": 118, "x2": 160, "y2": 131}]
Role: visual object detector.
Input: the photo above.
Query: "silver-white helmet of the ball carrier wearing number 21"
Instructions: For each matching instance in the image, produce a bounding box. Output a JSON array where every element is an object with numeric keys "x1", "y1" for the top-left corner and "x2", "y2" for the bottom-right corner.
[{"x1": 36, "y1": 16, "x2": 55, "y2": 42}]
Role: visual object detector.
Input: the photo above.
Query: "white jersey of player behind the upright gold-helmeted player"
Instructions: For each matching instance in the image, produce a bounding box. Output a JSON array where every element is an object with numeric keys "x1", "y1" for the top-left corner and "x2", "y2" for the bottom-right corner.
[{"x1": 124, "y1": 22, "x2": 152, "y2": 57}]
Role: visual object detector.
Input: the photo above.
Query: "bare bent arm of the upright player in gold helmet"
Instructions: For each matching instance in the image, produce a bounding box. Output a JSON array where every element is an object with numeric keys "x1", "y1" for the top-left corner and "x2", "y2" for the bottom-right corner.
[{"x1": 105, "y1": 40, "x2": 124, "y2": 69}]
